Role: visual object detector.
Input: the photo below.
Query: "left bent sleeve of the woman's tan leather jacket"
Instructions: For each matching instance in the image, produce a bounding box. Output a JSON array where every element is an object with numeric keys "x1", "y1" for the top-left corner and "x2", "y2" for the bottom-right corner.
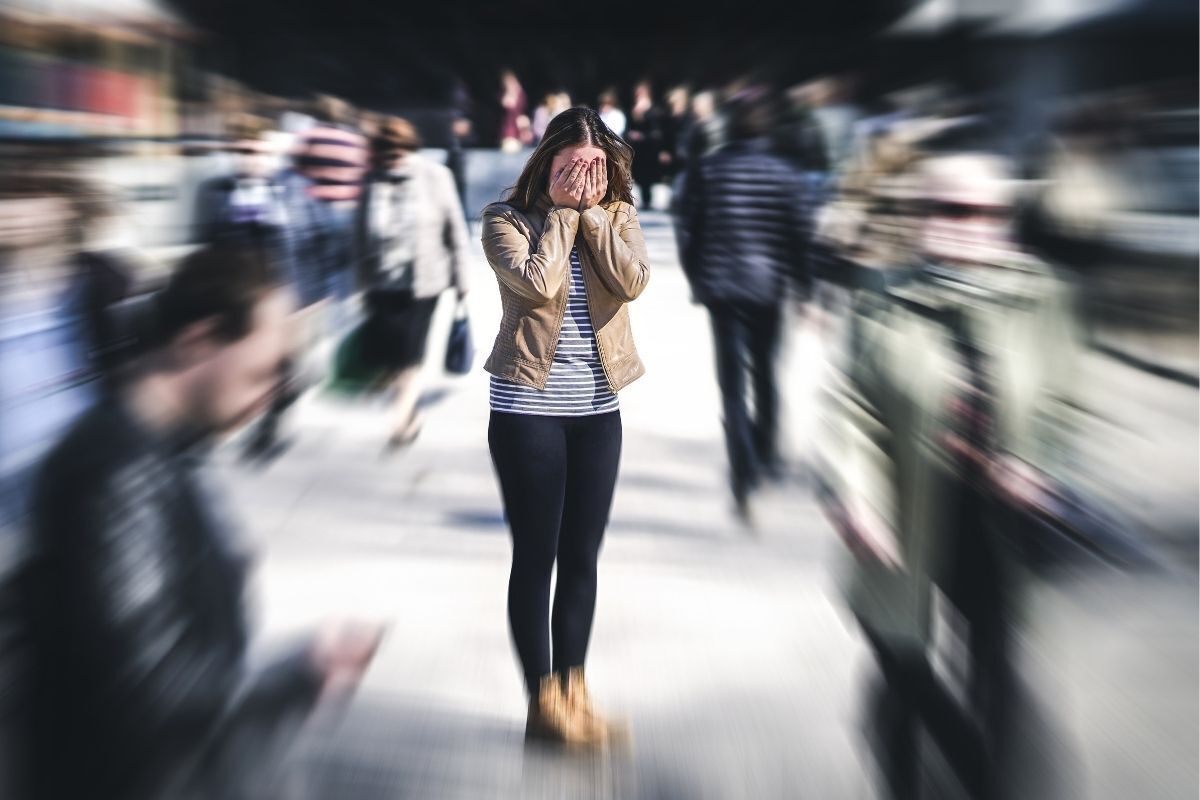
[{"x1": 482, "y1": 207, "x2": 580, "y2": 305}]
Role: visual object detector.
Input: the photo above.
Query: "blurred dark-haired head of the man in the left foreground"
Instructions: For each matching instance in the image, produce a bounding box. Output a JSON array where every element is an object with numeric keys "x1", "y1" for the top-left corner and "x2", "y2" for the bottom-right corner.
[{"x1": 140, "y1": 245, "x2": 293, "y2": 434}]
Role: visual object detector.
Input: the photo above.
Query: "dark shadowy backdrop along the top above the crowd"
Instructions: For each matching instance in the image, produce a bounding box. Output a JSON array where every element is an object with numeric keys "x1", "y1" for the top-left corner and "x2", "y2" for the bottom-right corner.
[{"x1": 168, "y1": 0, "x2": 1196, "y2": 145}]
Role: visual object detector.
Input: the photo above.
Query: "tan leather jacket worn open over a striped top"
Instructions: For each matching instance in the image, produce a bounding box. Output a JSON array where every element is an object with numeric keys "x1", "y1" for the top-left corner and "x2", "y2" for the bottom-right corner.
[{"x1": 482, "y1": 194, "x2": 650, "y2": 392}]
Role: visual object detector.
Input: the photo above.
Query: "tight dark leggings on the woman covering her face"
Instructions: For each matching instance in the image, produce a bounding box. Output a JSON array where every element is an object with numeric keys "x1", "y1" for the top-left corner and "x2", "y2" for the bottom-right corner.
[{"x1": 487, "y1": 411, "x2": 622, "y2": 694}]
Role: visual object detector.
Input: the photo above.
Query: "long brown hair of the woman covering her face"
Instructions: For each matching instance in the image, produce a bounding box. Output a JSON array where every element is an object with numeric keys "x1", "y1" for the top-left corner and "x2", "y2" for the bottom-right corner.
[{"x1": 505, "y1": 106, "x2": 634, "y2": 211}]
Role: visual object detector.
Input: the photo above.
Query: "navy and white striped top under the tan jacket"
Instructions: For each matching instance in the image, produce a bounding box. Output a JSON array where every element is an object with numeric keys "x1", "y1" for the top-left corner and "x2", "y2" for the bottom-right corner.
[{"x1": 491, "y1": 248, "x2": 618, "y2": 416}]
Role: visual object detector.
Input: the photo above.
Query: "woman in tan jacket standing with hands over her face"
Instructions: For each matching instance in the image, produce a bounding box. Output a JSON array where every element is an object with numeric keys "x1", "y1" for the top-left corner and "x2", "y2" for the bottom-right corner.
[{"x1": 482, "y1": 108, "x2": 649, "y2": 746}]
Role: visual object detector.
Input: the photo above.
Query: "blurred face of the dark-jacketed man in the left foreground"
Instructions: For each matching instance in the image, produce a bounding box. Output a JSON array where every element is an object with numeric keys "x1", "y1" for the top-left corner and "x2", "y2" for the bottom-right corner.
[{"x1": 193, "y1": 290, "x2": 293, "y2": 432}]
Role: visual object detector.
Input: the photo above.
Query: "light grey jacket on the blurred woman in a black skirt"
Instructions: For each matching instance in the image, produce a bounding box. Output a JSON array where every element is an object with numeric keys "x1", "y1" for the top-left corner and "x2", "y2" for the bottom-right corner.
[{"x1": 355, "y1": 154, "x2": 468, "y2": 299}]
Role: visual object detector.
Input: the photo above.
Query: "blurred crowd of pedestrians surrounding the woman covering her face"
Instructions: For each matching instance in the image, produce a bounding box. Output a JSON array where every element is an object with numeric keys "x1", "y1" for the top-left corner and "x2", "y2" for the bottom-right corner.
[{"x1": 0, "y1": 0, "x2": 1200, "y2": 798}]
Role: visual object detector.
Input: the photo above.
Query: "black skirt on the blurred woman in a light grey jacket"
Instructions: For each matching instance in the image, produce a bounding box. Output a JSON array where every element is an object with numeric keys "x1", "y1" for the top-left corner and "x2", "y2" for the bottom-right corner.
[{"x1": 362, "y1": 289, "x2": 438, "y2": 369}]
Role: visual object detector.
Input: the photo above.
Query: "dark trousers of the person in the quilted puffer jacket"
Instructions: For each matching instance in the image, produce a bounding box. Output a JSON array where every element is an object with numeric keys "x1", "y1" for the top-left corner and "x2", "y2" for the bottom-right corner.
[{"x1": 708, "y1": 302, "x2": 782, "y2": 499}]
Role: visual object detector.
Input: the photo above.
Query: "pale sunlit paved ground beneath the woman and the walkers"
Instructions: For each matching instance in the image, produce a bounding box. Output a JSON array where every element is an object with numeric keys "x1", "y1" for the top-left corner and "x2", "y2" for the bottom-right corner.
[{"x1": 221, "y1": 209, "x2": 1200, "y2": 800}]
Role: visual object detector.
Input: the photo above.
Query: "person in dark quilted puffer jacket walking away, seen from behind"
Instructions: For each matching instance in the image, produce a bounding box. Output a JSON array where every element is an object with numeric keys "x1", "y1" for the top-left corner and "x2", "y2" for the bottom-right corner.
[{"x1": 676, "y1": 92, "x2": 810, "y2": 521}]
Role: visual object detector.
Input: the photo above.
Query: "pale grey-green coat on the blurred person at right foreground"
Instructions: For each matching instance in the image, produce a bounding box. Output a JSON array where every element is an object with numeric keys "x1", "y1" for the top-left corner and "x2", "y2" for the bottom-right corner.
[{"x1": 815, "y1": 261, "x2": 1079, "y2": 650}]
